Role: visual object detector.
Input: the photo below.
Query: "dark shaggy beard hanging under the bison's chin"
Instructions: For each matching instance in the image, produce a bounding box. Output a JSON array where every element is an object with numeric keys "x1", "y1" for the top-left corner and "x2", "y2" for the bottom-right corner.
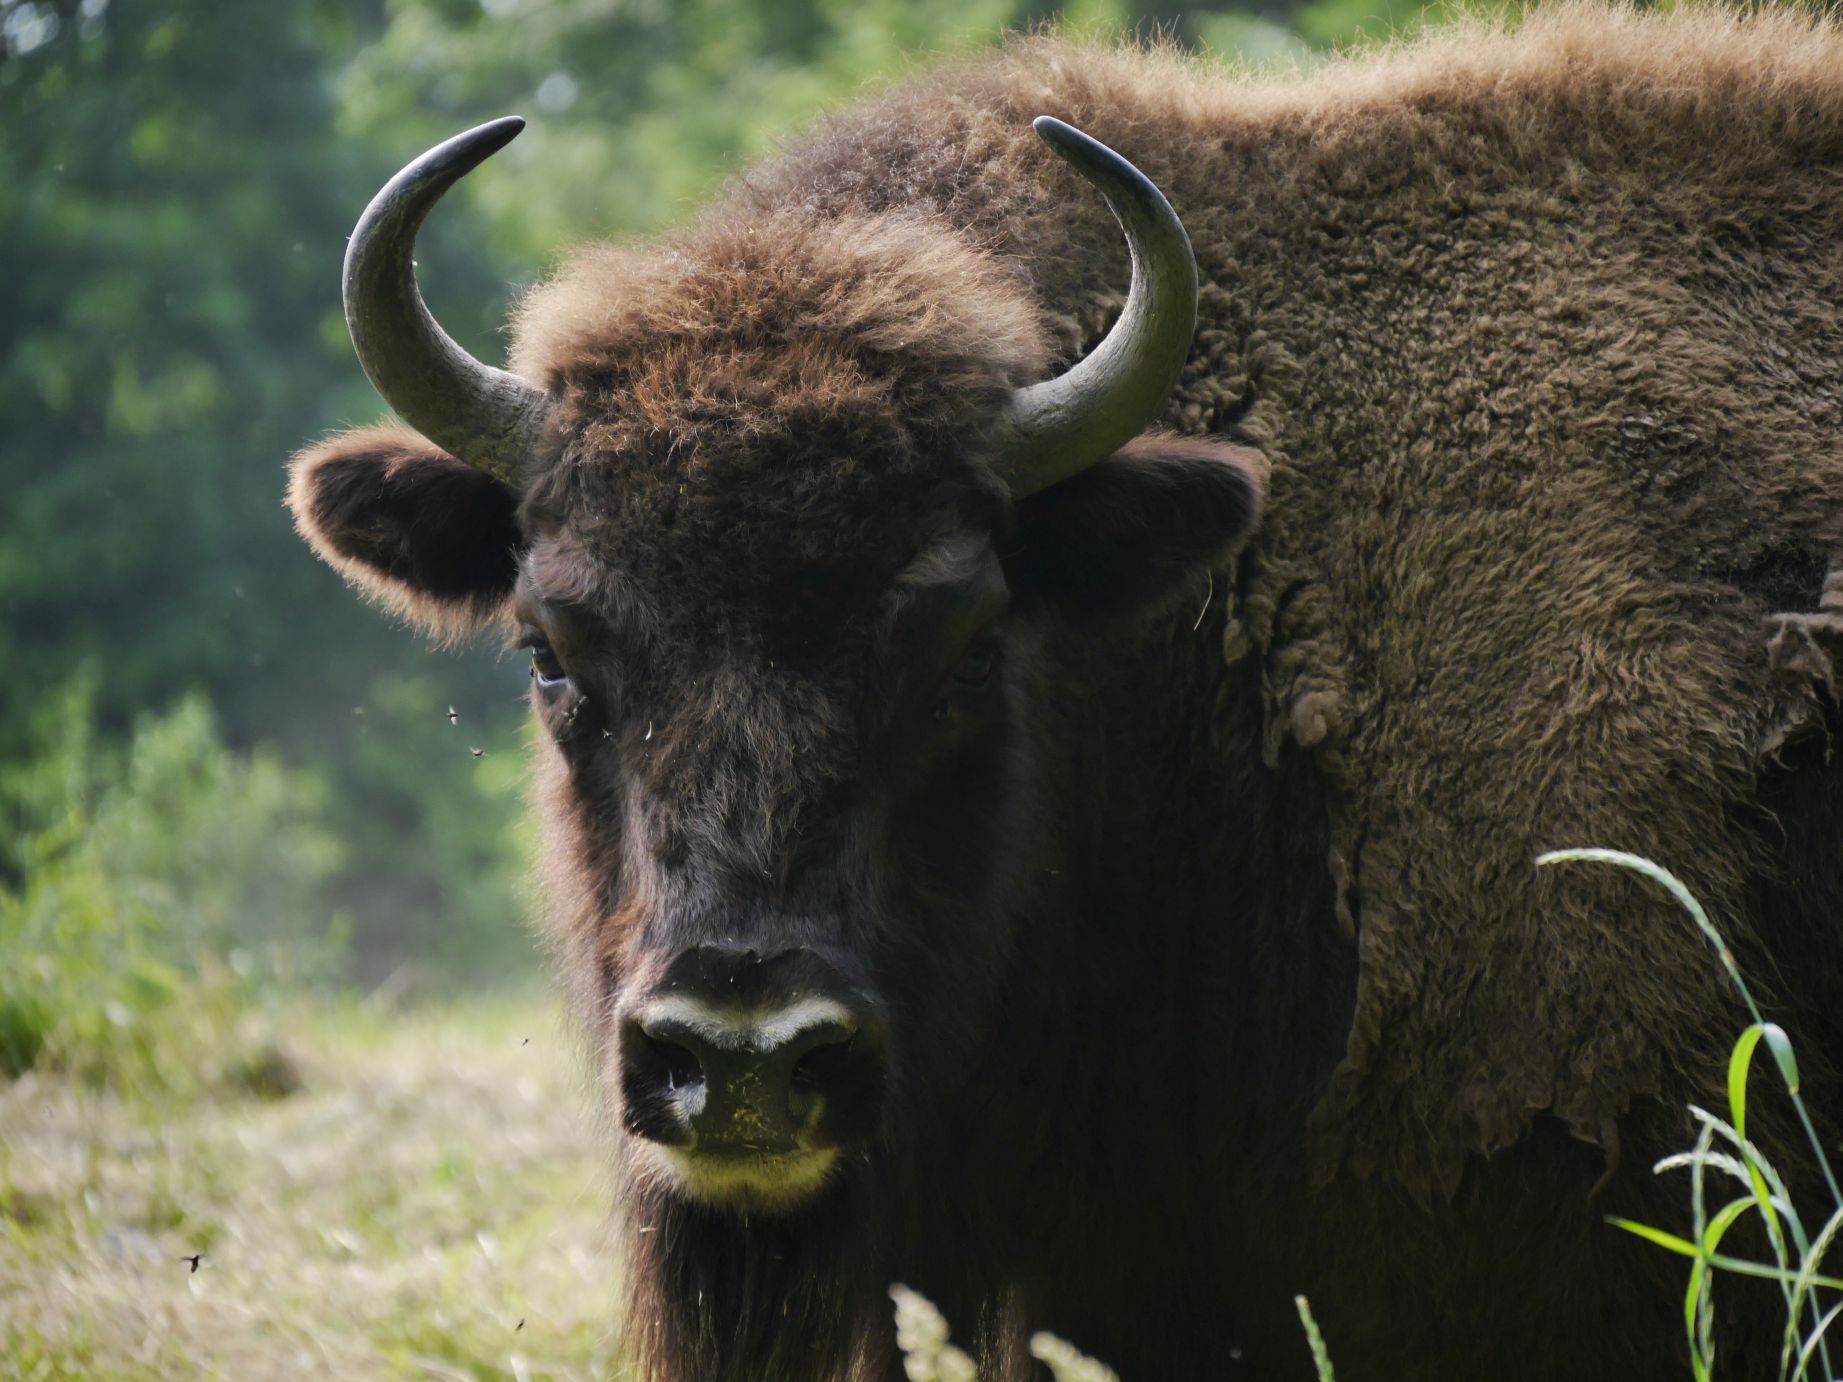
[{"x1": 621, "y1": 1155, "x2": 898, "y2": 1382}]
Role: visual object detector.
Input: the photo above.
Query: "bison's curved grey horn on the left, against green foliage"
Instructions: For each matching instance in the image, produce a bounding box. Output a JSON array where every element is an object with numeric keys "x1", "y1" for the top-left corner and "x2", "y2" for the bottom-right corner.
[{"x1": 345, "y1": 116, "x2": 546, "y2": 481}]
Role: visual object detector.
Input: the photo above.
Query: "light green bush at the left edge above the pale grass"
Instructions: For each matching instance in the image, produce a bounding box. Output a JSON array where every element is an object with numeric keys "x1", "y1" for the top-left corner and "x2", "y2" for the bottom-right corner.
[{"x1": 0, "y1": 676, "x2": 339, "y2": 1087}]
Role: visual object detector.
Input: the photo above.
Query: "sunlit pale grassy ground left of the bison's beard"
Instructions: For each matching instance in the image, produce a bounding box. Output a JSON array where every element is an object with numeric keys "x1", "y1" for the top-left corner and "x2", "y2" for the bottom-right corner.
[{"x1": 0, "y1": 999, "x2": 614, "y2": 1380}]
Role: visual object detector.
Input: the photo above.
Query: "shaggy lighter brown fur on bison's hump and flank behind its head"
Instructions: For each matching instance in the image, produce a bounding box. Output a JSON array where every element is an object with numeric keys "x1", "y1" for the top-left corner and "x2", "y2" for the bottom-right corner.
[{"x1": 745, "y1": 7, "x2": 1843, "y2": 1192}]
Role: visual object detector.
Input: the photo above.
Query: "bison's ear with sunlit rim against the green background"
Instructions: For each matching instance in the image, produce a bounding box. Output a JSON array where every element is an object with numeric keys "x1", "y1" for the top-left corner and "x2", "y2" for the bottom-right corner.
[{"x1": 288, "y1": 426, "x2": 523, "y2": 639}]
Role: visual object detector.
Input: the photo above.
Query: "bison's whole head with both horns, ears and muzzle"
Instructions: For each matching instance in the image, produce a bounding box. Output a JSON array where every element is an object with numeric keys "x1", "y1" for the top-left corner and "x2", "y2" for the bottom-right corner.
[{"x1": 289, "y1": 125, "x2": 1261, "y2": 1211}]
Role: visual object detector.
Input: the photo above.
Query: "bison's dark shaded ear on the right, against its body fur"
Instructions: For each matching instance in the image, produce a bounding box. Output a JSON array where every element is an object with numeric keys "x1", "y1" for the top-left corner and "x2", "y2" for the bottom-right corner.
[{"x1": 1004, "y1": 435, "x2": 1266, "y2": 617}]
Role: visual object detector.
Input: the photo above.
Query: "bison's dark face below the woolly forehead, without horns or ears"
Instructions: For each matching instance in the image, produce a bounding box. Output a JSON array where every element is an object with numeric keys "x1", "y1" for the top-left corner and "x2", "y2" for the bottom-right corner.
[{"x1": 516, "y1": 515, "x2": 1027, "y2": 1209}]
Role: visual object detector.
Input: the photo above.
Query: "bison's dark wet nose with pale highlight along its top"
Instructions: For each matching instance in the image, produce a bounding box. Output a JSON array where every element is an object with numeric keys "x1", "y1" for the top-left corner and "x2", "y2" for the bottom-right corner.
[{"x1": 621, "y1": 991, "x2": 883, "y2": 1155}]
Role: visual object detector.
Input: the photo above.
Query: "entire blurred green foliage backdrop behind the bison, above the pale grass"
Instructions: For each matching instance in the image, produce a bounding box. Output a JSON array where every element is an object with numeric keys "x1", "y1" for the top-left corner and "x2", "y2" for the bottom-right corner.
[{"x1": 0, "y1": 0, "x2": 1452, "y2": 1046}]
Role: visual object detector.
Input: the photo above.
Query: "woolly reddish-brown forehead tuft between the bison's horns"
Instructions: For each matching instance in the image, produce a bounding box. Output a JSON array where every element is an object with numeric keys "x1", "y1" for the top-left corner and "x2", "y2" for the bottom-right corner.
[{"x1": 514, "y1": 214, "x2": 1047, "y2": 603}]
